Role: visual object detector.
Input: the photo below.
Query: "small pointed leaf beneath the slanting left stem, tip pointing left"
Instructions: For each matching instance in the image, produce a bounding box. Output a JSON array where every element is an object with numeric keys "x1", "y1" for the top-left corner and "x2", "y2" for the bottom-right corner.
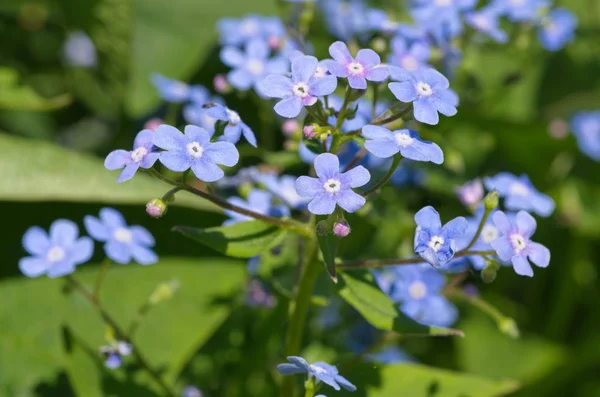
[{"x1": 173, "y1": 221, "x2": 286, "y2": 258}]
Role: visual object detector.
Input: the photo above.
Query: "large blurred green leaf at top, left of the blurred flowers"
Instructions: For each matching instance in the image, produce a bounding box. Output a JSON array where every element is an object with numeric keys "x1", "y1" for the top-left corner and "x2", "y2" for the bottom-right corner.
[{"x1": 126, "y1": 0, "x2": 276, "y2": 116}]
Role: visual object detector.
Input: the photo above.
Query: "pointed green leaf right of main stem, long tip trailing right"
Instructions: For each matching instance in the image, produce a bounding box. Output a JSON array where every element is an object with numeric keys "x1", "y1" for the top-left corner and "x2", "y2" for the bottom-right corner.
[{"x1": 338, "y1": 272, "x2": 463, "y2": 336}]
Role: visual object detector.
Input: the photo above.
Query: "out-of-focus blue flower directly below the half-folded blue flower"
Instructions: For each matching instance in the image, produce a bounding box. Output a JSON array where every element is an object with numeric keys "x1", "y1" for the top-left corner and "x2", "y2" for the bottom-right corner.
[{"x1": 374, "y1": 265, "x2": 458, "y2": 327}]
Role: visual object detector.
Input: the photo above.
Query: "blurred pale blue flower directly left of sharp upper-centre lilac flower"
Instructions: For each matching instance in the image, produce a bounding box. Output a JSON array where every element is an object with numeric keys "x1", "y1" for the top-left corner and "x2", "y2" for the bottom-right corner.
[{"x1": 221, "y1": 39, "x2": 287, "y2": 95}]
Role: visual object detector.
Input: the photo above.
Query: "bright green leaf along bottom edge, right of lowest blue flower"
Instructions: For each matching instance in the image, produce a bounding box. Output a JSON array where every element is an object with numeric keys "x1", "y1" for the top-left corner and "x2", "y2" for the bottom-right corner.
[{"x1": 340, "y1": 364, "x2": 519, "y2": 397}]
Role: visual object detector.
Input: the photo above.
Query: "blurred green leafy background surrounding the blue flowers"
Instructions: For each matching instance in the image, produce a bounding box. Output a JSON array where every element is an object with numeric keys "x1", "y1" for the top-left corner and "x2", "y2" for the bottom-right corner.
[{"x1": 0, "y1": 0, "x2": 600, "y2": 397}]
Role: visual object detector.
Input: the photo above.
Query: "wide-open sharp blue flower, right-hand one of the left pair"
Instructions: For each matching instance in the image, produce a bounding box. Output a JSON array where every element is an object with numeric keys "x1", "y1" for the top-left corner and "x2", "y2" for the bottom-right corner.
[{"x1": 152, "y1": 125, "x2": 240, "y2": 182}]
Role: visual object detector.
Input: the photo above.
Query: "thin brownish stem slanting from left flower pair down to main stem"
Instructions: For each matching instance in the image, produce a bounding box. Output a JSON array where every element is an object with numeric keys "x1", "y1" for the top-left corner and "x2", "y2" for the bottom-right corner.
[{"x1": 148, "y1": 168, "x2": 313, "y2": 237}]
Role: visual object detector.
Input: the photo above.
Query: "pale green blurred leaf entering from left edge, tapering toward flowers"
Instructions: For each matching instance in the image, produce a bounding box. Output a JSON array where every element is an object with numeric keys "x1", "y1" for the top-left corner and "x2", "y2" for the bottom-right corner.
[{"x1": 0, "y1": 134, "x2": 218, "y2": 211}]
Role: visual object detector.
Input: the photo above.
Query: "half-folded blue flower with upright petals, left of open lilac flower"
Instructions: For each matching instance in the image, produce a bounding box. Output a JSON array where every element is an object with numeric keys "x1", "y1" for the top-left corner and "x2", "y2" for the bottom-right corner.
[{"x1": 414, "y1": 206, "x2": 468, "y2": 268}]
